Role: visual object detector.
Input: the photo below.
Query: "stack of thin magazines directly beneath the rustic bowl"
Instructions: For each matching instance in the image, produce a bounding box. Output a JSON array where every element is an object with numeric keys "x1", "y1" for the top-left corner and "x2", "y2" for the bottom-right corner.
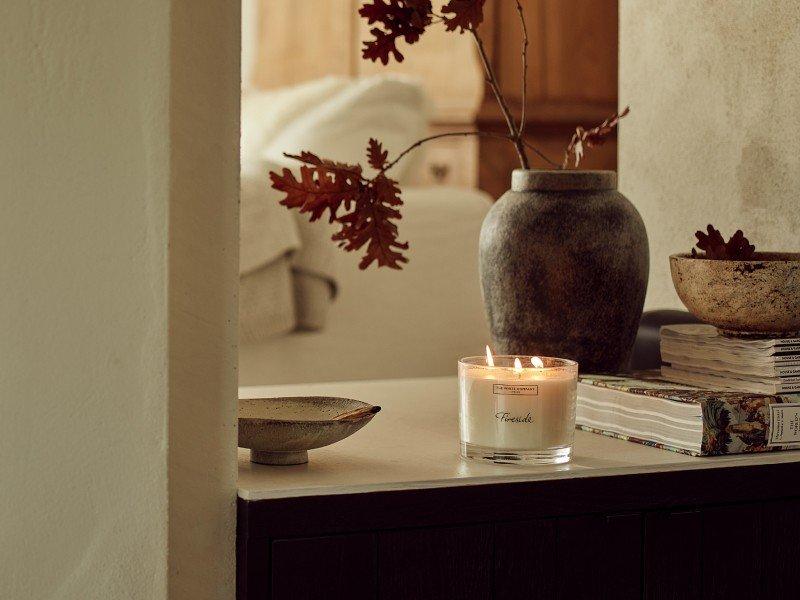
[{"x1": 661, "y1": 325, "x2": 800, "y2": 394}]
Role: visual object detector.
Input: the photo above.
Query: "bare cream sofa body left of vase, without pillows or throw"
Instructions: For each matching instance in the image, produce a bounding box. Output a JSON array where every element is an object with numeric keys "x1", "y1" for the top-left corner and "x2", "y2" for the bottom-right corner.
[{"x1": 239, "y1": 188, "x2": 491, "y2": 385}]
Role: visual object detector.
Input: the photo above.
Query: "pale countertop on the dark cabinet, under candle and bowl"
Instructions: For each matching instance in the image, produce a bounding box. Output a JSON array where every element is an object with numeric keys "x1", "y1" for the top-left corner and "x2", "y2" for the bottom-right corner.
[{"x1": 238, "y1": 377, "x2": 800, "y2": 500}]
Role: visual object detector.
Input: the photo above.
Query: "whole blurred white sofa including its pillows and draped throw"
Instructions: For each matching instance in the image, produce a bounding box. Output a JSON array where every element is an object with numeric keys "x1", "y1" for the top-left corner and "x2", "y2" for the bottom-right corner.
[{"x1": 239, "y1": 76, "x2": 491, "y2": 385}]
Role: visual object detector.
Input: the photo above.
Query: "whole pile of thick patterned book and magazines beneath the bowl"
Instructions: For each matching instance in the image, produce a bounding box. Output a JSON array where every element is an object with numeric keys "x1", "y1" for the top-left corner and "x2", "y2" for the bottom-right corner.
[{"x1": 576, "y1": 325, "x2": 800, "y2": 456}]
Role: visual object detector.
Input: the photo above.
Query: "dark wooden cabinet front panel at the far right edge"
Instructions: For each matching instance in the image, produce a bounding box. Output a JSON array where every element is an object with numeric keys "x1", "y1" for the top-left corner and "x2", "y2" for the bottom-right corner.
[{"x1": 760, "y1": 499, "x2": 800, "y2": 598}]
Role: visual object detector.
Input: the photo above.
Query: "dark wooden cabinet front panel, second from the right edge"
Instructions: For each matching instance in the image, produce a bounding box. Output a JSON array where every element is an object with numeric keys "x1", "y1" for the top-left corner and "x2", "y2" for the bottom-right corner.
[{"x1": 702, "y1": 504, "x2": 764, "y2": 600}]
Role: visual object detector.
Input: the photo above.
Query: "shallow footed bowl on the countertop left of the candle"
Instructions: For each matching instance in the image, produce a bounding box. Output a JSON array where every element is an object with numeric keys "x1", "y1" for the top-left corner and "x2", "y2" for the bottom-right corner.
[{"x1": 239, "y1": 396, "x2": 381, "y2": 465}]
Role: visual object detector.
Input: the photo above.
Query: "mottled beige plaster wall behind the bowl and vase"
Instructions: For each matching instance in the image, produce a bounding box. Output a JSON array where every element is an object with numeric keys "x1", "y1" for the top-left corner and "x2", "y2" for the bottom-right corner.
[{"x1": 619, "y1": 0, "x2": 800, "y2": 308}]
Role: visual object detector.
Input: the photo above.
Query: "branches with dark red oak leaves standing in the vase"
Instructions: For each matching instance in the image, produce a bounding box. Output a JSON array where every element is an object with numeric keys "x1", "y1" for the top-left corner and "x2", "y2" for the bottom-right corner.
[{"x1": 270, "y1": 0, "x2": 628, "y2": 269}]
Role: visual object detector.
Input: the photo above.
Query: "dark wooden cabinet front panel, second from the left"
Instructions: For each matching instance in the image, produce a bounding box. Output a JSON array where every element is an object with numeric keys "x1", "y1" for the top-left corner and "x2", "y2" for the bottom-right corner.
[{"x1": 378, "y1": 525, "x2": 492, "y2": 600}]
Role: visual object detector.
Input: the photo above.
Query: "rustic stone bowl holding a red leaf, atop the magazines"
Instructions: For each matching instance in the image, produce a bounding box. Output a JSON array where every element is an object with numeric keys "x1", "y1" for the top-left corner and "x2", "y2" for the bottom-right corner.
[{"x1": 669, "y1": 252, "x2": 800, "y2": 338}]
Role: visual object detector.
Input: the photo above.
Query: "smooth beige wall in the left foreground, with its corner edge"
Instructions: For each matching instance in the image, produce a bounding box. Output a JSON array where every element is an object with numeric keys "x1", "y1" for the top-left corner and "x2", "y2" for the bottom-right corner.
[{"x1": 0, "y1": 0, "x2": 239, "y2": 600}]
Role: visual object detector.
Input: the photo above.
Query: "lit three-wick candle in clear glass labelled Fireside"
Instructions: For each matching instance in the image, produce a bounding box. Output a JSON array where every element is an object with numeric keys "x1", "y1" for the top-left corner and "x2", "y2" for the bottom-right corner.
[{"x1": 458, "y1": 355, "x2": 578, "y2": 464}]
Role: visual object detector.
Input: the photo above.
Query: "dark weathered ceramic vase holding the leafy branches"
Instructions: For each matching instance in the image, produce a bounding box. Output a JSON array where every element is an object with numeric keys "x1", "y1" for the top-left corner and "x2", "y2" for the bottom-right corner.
[{"x1": 480, "y1": 170, "x2": 650, "y2": 373}]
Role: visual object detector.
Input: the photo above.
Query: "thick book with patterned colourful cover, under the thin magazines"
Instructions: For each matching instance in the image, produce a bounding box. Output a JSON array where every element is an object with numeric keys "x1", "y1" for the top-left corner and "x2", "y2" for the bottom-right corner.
[{"x1": 577, "y1": 371, "x2": 800, "y2": 456}]
